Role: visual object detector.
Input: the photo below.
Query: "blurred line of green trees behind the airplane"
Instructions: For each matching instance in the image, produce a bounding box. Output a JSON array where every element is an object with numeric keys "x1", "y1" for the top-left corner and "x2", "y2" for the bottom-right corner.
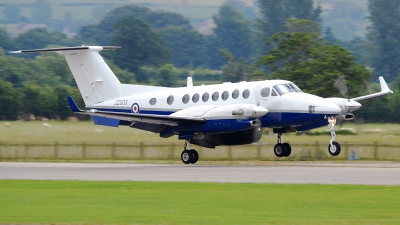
[{"x1": 0, "y1": 0, "x2": 400, "y2": 122}]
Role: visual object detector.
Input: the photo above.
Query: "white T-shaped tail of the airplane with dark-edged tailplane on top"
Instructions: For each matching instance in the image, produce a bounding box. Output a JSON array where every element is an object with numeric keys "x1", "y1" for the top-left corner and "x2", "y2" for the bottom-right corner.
[{"x1": 12, "y1": 46, "x2": 123, "y2": 106}]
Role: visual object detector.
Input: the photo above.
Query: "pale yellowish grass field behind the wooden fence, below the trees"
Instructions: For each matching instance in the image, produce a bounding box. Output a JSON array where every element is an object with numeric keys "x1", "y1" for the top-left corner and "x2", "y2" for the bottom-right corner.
[{"x1": 0, "y1": 121, "x2": 400, "y2": 144}]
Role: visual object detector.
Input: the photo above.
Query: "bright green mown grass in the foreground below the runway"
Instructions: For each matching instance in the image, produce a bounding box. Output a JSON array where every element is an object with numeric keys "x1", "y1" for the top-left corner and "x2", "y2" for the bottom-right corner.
[{"x1": 0, "y1": 180, "x2": 400, "y2": 224}]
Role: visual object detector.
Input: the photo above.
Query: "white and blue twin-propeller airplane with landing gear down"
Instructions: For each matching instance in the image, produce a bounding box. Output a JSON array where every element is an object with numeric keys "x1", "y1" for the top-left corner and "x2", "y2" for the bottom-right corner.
[{"x1": 12, "y1": 46, "x2": 393, "y2": 164}]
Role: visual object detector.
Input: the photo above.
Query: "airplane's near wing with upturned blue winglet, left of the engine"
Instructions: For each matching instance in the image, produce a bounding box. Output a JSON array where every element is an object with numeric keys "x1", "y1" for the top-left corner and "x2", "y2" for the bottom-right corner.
[{"x1": 67, "y1": 96, "x2": 207, "y2": 126}]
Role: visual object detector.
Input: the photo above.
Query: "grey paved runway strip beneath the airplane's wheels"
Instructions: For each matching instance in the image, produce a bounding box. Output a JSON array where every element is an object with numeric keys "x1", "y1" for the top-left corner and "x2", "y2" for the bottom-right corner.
[{"x1": 0, "y1": 162, "x2": 400, "y2": 185}]
